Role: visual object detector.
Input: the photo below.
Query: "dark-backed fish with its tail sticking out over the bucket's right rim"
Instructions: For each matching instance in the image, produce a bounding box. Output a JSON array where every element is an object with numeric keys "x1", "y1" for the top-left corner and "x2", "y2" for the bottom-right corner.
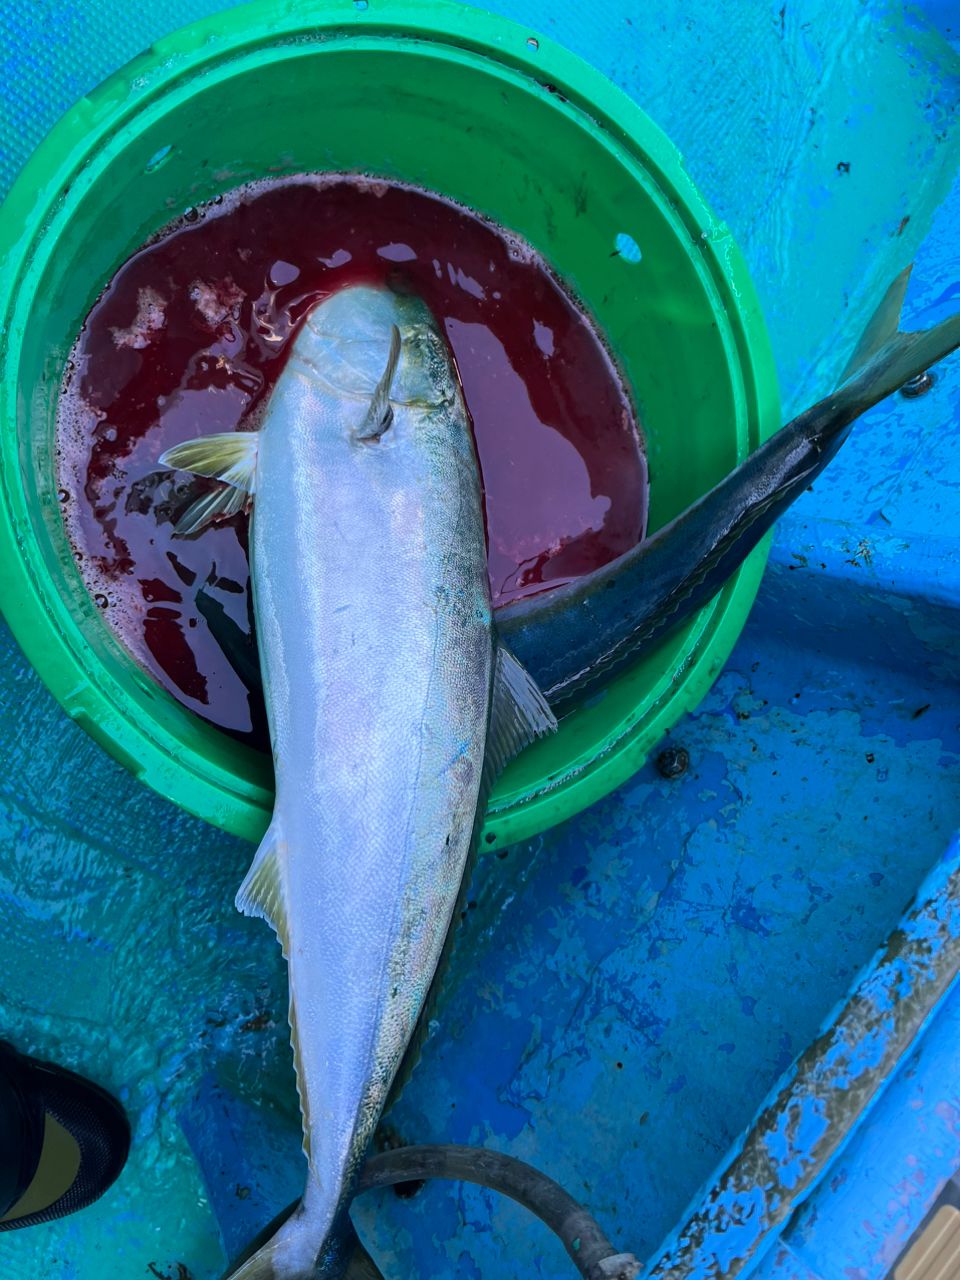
[{"x1": 198, "y1": 268, "x2": 960, "y2": 716}]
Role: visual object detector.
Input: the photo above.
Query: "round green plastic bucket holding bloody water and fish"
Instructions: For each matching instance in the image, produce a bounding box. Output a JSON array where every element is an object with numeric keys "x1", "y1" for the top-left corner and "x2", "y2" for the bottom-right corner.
[{"x1": 0, "y1": 0, "x2": 778, "y2": 849}]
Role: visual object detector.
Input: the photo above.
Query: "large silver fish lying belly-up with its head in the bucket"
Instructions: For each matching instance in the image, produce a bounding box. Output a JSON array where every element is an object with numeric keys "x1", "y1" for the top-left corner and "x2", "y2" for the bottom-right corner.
[{"x1": 160, "y1": 285, "x2": 557, "y2": 1280}]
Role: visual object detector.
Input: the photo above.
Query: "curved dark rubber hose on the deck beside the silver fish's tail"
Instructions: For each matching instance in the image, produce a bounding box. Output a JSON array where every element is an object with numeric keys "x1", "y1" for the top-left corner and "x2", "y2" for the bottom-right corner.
[{"x1": 357, "y1": 1146, "x2": 640, "y2": 1280}]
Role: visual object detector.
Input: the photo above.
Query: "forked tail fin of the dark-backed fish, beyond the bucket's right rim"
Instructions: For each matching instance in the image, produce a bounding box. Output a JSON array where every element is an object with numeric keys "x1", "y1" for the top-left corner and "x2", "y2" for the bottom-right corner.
[{"x1": 837, "y1": 266, "x2": 960, "y2": 415}]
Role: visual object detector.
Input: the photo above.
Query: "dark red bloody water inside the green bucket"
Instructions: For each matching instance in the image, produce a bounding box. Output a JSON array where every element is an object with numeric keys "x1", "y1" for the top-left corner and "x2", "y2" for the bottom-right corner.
[{"x1": 58, "y1": 175, "x2": 646, "y2": 745}]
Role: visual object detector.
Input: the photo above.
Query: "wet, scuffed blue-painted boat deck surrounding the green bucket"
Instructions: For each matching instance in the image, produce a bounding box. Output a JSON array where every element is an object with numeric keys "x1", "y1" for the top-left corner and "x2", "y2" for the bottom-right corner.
[{"x1": 0, "y1": 0, "x2": 960, "y2": 1280}]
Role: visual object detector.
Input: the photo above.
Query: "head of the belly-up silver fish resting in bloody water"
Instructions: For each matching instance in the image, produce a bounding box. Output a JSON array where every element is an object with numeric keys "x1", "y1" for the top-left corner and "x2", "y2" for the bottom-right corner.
[{"x1": 291, "y1": 285, "x2": 461, "y2": 442}]
